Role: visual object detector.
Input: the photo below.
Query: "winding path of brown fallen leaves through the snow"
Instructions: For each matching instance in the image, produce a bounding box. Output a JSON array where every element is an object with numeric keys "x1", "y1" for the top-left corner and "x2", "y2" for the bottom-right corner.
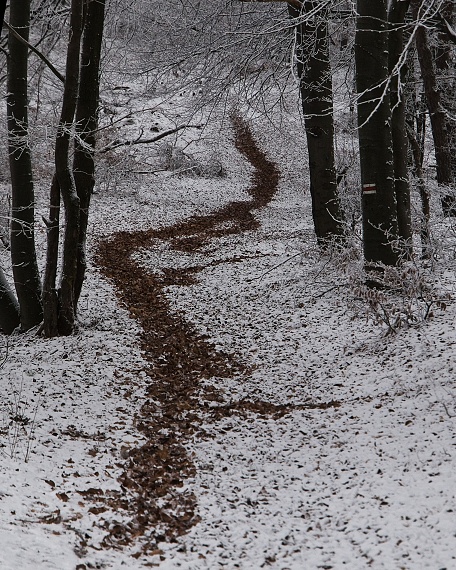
[{"x1": 97, "y1": 116, "x2": 339, "y2": 552}]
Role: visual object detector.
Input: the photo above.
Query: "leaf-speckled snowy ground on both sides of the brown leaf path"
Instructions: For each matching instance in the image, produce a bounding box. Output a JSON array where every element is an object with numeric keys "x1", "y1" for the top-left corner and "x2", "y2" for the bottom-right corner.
[{"x1": 0, "y1": 85, "x2": 456, "y2": 570}]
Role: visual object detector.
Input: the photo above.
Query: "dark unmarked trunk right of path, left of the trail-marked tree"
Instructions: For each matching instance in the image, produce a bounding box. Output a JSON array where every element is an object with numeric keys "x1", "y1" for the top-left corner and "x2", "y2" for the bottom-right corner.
[{"x1": 288, "y1": 0, "x2": 344, "y2": 244}]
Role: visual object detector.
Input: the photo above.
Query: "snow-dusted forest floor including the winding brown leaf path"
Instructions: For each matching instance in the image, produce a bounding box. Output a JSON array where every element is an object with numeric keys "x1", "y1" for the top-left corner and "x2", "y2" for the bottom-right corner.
[{"x1": 0, "y1": 94, "x2": 456, "y2": 570}]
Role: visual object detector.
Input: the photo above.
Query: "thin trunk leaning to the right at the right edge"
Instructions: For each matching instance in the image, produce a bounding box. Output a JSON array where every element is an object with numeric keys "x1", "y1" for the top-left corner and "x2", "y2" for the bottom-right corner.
[{"x1": 412, "y1": 0, "x2": 456, "y2": 216}]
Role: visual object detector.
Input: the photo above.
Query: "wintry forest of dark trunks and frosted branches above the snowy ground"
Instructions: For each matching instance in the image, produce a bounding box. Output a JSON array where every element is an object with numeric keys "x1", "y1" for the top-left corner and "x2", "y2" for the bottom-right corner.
[{"x1": 0, "y1": 0, "x2": 456, "y2": 337}]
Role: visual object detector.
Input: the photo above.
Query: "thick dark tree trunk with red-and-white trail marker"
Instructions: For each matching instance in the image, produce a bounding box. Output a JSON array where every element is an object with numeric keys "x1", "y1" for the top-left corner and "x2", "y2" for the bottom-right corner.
[{"x1": 355, "y1": 0, "x2": 398, "y2": 265}]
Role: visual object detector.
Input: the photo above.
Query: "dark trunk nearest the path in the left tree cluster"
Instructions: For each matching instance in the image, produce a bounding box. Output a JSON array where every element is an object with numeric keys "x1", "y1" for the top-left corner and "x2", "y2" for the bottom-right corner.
[{"x1": 73, "y1": 0, "x2": 105, "y2": 310}]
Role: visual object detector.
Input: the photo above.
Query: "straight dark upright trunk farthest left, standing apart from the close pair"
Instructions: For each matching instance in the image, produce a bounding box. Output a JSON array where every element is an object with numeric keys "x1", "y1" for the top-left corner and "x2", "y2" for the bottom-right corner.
[{"x1": 7, "y1": 0, "x2": 43, "y2": 330}]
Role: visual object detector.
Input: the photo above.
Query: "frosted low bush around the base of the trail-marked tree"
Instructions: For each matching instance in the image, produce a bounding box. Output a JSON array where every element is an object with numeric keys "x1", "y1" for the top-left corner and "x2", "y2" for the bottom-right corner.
[{"x1": 303, "y1": 234, "x2": 452, "y2": 335}]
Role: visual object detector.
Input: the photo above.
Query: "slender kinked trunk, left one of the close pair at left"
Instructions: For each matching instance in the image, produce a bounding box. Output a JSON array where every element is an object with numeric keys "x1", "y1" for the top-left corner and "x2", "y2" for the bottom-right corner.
[{"x1": 55, "y1": 0, "x2": 83, "y2": 335}]
